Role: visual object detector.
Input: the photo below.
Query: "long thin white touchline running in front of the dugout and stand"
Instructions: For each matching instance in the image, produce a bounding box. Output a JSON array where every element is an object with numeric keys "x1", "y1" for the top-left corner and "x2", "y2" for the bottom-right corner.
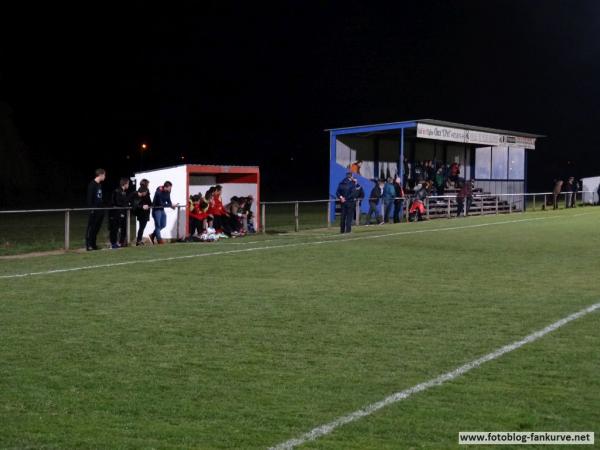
[{"x1": 0, "y1": 216, "x2": 580, "y2": 280}]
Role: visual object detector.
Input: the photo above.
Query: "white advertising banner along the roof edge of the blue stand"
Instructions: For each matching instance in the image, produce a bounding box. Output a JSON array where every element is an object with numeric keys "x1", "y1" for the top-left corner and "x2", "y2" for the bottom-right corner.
[{"x1": 417, "y1": 123, "x2": 535, "y2": 149}]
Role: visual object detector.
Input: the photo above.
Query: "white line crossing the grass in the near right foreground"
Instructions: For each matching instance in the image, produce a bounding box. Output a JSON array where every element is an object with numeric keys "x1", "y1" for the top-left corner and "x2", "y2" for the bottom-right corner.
[{"x1": 270, "y1": 303, "x2": 600, "y2": 450}]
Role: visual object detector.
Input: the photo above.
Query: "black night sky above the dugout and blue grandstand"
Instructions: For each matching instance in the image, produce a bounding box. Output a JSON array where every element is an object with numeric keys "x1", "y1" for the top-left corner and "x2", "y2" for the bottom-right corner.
[{"x1": 0, "y1": 0, "x2": 600, "y2": 206}]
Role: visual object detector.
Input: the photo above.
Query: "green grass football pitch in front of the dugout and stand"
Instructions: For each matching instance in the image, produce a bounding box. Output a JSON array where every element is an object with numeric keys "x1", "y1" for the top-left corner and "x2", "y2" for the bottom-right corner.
[{"x1": 0, "y1": 208, "x2": 600, "y2": 449}]
